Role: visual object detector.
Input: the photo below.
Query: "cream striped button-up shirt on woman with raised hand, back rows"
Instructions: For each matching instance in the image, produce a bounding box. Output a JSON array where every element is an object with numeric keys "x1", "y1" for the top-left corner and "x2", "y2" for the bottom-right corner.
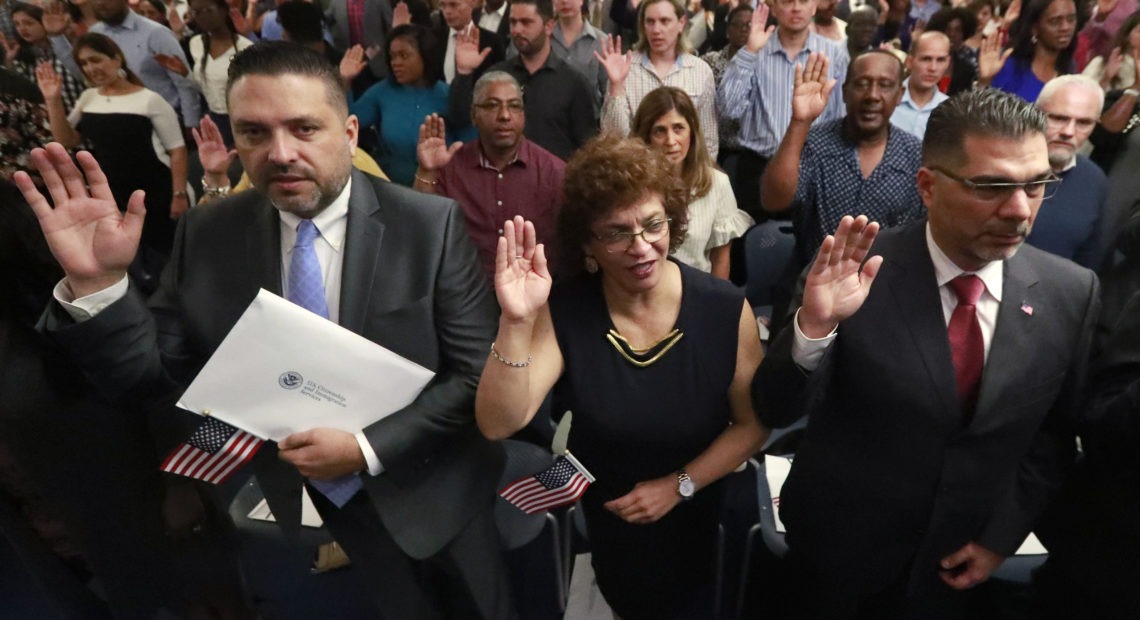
[{"x1": 602, "y1": 51, "x2": 719, "y2": 161}]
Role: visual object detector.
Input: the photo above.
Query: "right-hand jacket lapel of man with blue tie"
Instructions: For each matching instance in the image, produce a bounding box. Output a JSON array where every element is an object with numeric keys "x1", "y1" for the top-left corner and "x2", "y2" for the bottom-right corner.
[{"x1": 340, "y1": 170, "x2": 384, "y2": 334}]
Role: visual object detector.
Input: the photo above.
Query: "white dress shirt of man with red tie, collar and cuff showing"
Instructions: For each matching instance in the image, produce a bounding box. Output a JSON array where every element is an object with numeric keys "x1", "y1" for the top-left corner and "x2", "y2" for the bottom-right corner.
[{"x1": 791, "y1": 222, "x2": 1004, "y2": 372}]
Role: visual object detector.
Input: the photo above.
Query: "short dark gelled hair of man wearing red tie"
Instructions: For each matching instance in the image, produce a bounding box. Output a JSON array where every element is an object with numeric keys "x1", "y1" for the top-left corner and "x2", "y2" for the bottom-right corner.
[{"x1": 922, "y1": 88, "x2": 1045, "y2": 166}]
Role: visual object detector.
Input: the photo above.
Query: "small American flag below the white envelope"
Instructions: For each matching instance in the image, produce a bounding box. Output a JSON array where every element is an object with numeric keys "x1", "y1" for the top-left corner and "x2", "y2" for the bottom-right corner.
[{"x1": 162, "y1": 417, "x2": 262, "y2": 484}]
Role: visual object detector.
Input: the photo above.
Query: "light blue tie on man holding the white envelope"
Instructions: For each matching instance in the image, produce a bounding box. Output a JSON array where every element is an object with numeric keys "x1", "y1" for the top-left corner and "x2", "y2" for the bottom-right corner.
[{"x1": 288, "y1": 220, "x2": 364, "y2": 508}]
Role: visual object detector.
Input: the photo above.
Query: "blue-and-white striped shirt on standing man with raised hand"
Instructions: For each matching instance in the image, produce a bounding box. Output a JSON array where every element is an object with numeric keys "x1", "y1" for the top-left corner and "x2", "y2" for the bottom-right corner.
[{"x1": 717, "y1": 31, "x2": 850, "y2": 157}]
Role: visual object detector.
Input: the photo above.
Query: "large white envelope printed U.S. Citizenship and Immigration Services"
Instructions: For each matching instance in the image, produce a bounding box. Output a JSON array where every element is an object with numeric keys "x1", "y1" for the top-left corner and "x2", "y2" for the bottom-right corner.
[{"x1": 178, "y1": 289, "x2": 434, "y2": 441}]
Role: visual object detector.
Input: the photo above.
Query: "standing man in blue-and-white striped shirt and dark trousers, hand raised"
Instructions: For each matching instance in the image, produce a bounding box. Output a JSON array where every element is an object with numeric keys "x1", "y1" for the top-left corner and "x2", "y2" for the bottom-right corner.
[{"x1": 717, "y1": 0, "x2": 849, "y2": 216}]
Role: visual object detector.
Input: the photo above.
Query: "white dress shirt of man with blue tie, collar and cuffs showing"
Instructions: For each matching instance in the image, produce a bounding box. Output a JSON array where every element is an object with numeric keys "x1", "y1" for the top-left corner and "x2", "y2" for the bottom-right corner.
[{"x1": 54, "y1": 178, "x2": 384, "y2": 475}]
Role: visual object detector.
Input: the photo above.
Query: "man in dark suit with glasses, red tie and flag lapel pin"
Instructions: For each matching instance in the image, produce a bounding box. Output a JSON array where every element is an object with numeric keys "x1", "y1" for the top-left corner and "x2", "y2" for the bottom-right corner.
[{"x1": 754, "y1": 90, "x2": 1099, "y2": 619}]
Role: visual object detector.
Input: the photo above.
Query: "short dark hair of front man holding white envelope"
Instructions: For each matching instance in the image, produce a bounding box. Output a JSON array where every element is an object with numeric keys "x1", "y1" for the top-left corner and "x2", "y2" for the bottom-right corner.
[{"x1": 226, "y1": 41, "x2": 349, "y2": 116}]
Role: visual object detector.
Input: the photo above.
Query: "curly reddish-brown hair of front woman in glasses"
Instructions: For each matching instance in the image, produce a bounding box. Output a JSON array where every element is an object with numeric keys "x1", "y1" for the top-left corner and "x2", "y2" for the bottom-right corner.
[{"x1": 556, "y1": 134, "x2": 689, "y2": 276}]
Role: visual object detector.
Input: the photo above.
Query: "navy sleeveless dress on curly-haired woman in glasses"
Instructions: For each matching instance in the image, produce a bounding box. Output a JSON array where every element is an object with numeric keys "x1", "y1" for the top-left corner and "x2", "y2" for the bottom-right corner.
[{"x1": 549, "y1": 261, "x2": 744, "y2": 620}]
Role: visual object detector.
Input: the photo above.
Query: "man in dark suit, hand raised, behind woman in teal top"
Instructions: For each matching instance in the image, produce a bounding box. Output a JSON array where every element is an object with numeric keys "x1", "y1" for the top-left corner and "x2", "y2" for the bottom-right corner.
[{"x1": 434, "y1": 0, "x2": 510, "y2": 84}]
